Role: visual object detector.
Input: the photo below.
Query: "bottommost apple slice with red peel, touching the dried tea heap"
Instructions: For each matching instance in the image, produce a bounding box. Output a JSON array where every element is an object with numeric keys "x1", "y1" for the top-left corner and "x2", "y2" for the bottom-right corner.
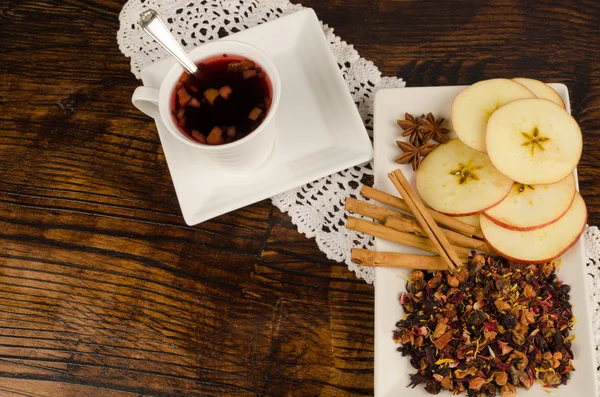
[{"x1": 479, "y1": 193, "x2": 587, "y2": 263}]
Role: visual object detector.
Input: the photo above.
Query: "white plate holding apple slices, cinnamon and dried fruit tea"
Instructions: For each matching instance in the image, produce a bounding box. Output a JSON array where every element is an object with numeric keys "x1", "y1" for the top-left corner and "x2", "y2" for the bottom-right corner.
[{"x1": 374, "y1": 84, "x2": 598, "y2": 397}]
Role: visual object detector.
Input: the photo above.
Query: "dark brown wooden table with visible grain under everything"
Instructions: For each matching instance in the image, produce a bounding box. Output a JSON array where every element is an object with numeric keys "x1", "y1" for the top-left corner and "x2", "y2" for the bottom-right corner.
[{"x1": 0, "y1": 0, "x2": 600, "y2": 397}]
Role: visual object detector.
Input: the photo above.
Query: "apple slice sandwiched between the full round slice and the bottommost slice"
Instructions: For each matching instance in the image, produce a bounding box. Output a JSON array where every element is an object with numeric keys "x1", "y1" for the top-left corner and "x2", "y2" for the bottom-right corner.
[{"x1": 484, "y1": 174, "x2": 575, "y2": 230}]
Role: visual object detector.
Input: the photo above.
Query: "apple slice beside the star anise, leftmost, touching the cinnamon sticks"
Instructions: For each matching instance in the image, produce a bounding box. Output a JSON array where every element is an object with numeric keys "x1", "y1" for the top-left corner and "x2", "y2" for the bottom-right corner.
[{"x1": 416, "y1": 139, "x2": 513, "y2": 216}]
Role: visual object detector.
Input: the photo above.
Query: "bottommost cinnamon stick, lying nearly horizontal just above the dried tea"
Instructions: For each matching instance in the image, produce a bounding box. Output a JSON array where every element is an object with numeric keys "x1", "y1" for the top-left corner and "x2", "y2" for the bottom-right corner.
[{"x1": 350, "y1": 248, "x2": 467, "y2": 271}]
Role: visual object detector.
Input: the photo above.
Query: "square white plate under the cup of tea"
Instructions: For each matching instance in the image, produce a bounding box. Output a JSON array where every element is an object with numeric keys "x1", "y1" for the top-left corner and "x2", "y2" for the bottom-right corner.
[{"x1": 142, "y1": 9, "x2": 373, "y2": 225}]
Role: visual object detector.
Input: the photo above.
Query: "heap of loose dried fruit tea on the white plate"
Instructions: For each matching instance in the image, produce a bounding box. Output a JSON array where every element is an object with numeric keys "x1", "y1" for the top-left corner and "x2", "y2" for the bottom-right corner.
[{"x1": 393, "y1": 255, "x2": 574, "y2": 397}]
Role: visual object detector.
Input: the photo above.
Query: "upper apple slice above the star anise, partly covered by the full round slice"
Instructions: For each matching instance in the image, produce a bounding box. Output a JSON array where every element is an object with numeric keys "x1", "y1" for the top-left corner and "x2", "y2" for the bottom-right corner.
[{"x1": 452, "y1": 79, "x2": 535, "y2": 153}]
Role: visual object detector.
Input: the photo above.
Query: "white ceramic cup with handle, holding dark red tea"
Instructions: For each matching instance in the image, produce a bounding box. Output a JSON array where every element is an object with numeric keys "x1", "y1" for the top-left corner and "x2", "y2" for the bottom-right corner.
[{"x1": 132, "y1": 40, "x2": 281, "y2": 173}]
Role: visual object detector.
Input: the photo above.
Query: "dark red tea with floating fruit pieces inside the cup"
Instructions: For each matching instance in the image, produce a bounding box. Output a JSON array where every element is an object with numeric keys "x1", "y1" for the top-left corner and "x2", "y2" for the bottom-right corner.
[{"x1": 171, "y1": 54, "x2": 272, "y2": 145}]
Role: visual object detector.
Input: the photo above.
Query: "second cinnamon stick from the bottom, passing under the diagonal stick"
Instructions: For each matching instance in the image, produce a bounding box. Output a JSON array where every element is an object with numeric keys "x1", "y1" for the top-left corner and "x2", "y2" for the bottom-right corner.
[{"x1": 346, "y1": 216, "x2": 471, "y2": 259}]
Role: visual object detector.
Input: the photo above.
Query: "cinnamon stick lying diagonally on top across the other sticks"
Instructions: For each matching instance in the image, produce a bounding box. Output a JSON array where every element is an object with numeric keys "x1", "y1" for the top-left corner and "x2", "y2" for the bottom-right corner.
[{"x1": 388, "y1": 170, "x2": 462, "y2": 272}]
